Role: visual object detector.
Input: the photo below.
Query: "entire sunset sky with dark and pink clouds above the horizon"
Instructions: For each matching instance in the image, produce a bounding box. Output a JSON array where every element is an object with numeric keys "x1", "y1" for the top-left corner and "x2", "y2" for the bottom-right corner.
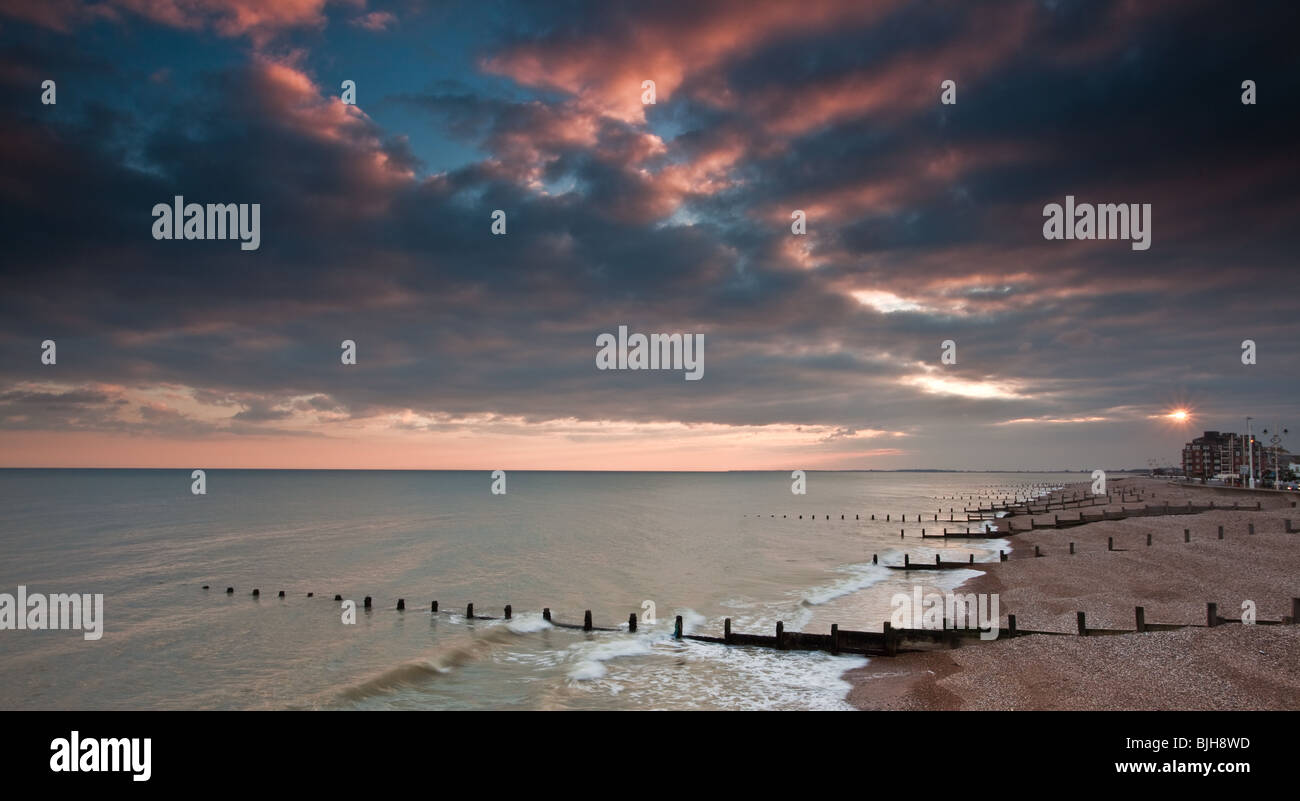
[{"x1": 0, "y1": 0, "x2": 1300, "y2": 469}]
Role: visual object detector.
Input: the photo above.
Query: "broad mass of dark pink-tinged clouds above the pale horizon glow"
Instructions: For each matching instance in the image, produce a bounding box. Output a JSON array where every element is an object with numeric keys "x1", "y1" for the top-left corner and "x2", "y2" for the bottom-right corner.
[{"x1": 0, "y1": 3, "x2": 1300, "y2": 462}]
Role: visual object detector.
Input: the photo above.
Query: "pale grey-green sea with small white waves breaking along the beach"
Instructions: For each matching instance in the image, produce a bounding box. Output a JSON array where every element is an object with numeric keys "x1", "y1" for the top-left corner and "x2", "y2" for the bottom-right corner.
[{"x1": 0, "y1": 469, "x2": 1080, "y2": 709}]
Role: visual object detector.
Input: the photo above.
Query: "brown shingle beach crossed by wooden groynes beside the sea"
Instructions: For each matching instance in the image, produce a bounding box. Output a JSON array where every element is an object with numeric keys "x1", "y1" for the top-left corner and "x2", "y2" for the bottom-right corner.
[{"x1": 844, "y1": 479, "x2": 1300, "y2": 710}]
